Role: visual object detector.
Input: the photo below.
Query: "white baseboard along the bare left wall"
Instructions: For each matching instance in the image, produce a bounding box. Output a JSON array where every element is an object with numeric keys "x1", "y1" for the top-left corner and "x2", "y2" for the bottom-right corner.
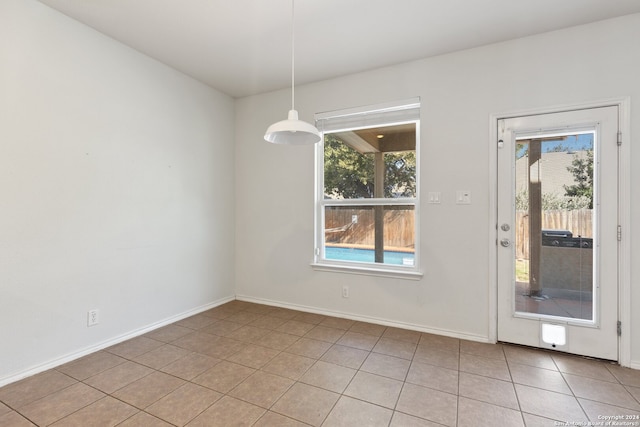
[{"x1": 0, "y1": 296, "x2": 235, "y2": 387}]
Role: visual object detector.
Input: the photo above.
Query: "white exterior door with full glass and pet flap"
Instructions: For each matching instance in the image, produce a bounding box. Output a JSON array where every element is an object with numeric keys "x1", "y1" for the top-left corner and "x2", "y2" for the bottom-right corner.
[{"x1": 497, "y1": 106, "x2": 618, "y2": 360}]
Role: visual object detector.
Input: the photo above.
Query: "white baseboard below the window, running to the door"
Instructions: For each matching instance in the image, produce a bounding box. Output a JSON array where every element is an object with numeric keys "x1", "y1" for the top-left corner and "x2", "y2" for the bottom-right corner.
[{"x1": 236, "y1": 295, "x2": 492, "y2": 343}]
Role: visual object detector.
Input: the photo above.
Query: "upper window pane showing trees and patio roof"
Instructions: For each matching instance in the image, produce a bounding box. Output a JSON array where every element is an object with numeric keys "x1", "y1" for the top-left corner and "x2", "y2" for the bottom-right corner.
[{"x1": 324, "y1": 123, "x2": 416, "y2": 200}]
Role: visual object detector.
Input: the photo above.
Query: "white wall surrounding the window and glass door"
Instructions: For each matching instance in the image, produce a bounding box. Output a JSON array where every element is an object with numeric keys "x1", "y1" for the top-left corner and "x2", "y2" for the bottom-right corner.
[{"x1": 236, "y1": 15, "x2": 640, "y2": 367}]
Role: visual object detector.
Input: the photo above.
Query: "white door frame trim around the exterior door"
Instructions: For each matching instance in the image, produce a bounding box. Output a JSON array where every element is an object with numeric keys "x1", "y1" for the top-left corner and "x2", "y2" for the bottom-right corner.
[{"x1": 488, "y1": 97, "x2": 631, "y2": 367}]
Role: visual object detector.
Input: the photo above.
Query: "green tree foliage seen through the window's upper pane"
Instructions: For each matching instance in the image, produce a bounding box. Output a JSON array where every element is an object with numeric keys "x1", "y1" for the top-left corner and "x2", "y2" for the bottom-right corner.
[{"x1": 324, "y1": 135, "x2": 416, "y2": 199}]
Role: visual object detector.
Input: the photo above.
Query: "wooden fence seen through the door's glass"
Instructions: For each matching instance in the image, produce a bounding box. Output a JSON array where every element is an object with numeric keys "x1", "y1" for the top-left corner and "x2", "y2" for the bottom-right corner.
[{"x1": 514, "y1": 209, "x2": 593, "y2": 259}]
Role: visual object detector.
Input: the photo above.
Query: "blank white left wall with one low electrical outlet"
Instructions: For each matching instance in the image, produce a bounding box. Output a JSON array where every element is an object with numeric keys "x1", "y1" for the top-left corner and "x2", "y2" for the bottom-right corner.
[{"x1": 0, "y1": 0, "x2": 235, "y2": 385}]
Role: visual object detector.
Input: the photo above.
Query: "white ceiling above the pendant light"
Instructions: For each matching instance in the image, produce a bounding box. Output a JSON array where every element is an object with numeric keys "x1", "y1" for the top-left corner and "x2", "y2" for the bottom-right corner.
[{"x1": 40, "y1": 0, "x2": 640, "y2": 97}]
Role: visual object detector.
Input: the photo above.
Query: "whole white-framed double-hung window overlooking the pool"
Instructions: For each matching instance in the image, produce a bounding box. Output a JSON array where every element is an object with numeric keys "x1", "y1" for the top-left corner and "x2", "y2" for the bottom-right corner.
[{"x1": 314, "y1": 99, "x2": 420, "y2": 275}]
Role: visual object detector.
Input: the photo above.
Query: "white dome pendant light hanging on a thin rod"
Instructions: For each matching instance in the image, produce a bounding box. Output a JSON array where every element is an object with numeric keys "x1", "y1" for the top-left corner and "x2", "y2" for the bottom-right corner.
[{"x1": 264, "y1": 0, "x2": 320, "y2": 145}]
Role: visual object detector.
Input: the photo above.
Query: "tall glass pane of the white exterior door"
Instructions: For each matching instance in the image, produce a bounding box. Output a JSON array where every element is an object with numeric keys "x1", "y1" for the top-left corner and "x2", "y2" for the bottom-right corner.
[{"x1": 513, "y1": 132, "x2": 597, "y2": 320}]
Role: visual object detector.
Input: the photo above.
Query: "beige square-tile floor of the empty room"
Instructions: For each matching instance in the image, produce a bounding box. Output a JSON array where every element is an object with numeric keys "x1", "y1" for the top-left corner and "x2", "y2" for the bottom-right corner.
[{"x1": 0, "y1": 301, "x2": 640, "y2": 427}]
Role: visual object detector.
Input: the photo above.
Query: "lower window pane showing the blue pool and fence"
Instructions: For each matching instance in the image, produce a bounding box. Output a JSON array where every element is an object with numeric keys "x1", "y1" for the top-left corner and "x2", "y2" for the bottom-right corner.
[{"x1": 325, "y1": 206, "x2": 415, "y2": 266}]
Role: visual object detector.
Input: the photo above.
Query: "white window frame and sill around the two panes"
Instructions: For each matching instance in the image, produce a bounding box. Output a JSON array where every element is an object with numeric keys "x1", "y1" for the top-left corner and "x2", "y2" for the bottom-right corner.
[{"x1": 311, "y1": 98, "x2": 422, "y2": 280}]
